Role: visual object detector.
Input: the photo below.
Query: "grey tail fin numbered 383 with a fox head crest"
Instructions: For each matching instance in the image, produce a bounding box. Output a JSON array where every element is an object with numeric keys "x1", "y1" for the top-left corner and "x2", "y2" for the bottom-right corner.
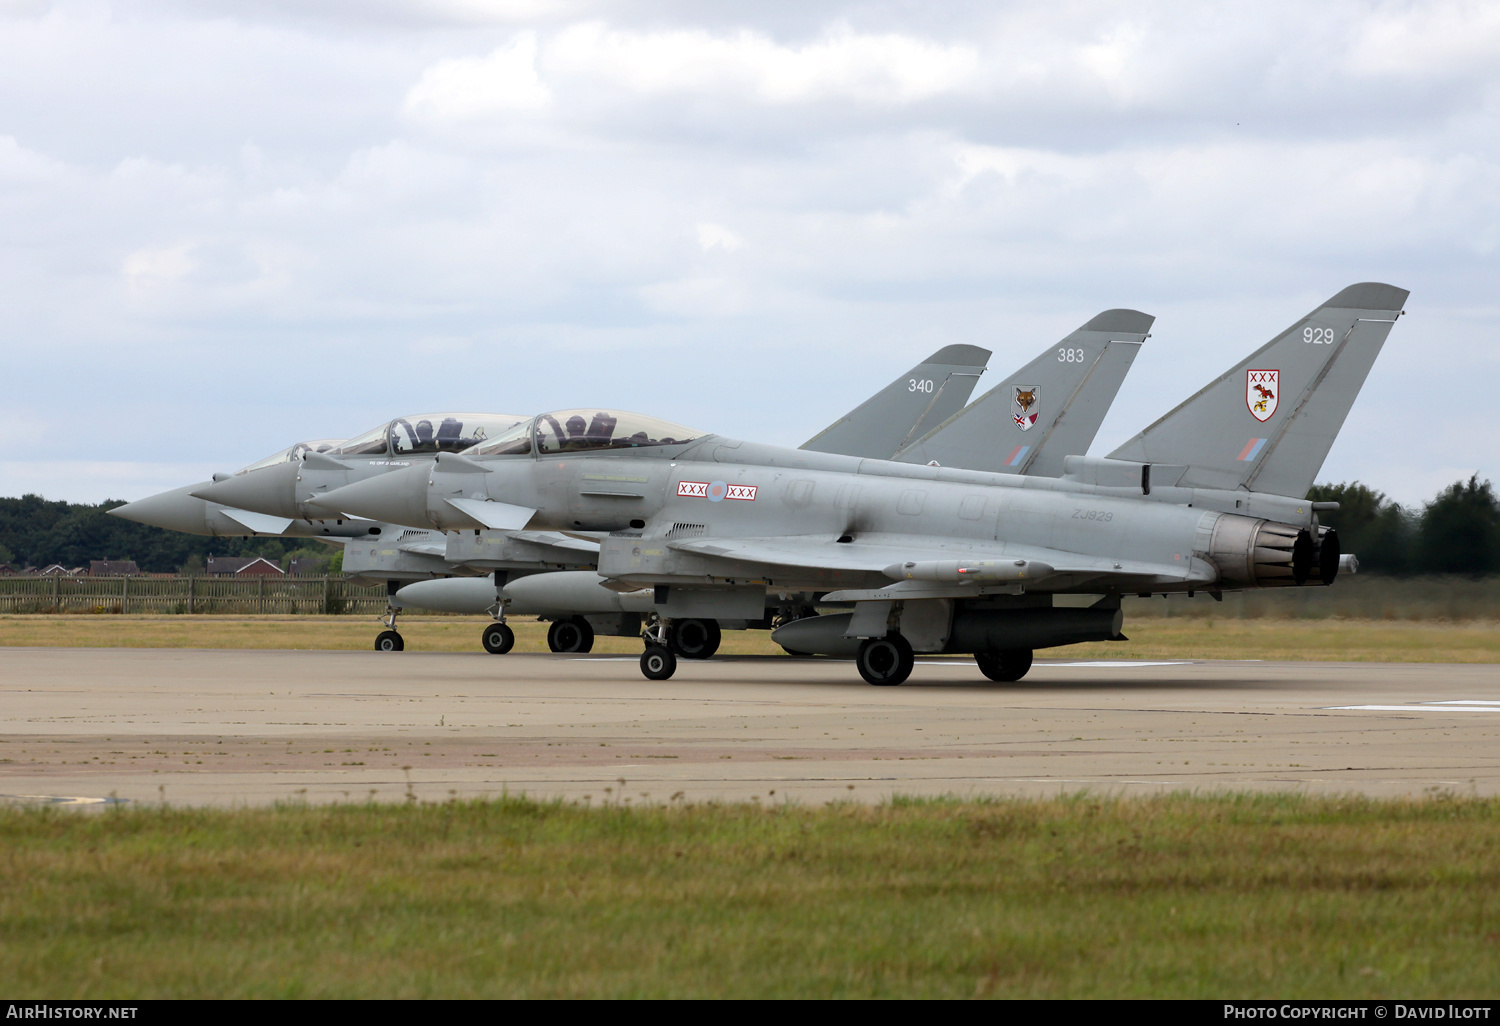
[{"x1": 896, "y1": 311, "x2": 1155, "y2": 477}]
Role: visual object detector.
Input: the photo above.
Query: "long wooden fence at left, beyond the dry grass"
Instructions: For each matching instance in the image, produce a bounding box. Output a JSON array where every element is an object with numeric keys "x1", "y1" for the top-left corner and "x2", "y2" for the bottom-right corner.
[{"x1": 0, "y1": 578, "x2": 386, "y2": 615}]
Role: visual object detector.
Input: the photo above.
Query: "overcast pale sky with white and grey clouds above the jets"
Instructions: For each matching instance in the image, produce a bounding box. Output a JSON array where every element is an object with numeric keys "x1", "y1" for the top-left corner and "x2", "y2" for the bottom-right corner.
[{"x1": 0, "y1": 0, "x2": 1500, "y2": 503}]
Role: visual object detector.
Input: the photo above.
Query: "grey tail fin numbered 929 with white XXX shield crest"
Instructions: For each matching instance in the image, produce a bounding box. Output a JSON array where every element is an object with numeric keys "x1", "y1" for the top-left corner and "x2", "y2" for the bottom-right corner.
[{"x1": 1110, "y1": 282, "x2": 1410, "y2": 498}]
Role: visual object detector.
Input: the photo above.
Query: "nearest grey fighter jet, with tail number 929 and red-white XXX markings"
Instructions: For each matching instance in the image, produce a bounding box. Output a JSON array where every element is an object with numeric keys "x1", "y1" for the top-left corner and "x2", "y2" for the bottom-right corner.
[{"x1": 315, "y1": 284, "x2": 1407, "y2": 684}]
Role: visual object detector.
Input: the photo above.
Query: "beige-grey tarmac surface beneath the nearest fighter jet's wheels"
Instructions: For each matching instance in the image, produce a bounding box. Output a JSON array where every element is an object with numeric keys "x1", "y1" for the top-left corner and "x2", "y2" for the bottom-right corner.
[{"x1": 0, "y1": 648, "x2": 1500, "y2": 806}]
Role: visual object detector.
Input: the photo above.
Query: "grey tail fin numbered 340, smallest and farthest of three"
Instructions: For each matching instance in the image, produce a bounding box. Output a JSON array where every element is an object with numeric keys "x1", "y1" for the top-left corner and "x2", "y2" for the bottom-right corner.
[{"x1": 803, "y1": 345, "x2": 990, "y2": 459}]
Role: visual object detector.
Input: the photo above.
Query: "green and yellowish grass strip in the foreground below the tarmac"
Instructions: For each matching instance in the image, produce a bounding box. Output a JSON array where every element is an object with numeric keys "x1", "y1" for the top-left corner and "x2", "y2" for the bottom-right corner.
[{"x1": 0, "y1": 795, "x2": 1500, "y2": 998}]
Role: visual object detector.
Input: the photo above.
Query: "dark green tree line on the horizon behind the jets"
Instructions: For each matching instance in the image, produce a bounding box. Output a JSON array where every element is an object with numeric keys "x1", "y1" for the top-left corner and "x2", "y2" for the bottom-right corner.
[{"x1": 0, "y1": 474, "x2": 1500, "y2": 575}]
